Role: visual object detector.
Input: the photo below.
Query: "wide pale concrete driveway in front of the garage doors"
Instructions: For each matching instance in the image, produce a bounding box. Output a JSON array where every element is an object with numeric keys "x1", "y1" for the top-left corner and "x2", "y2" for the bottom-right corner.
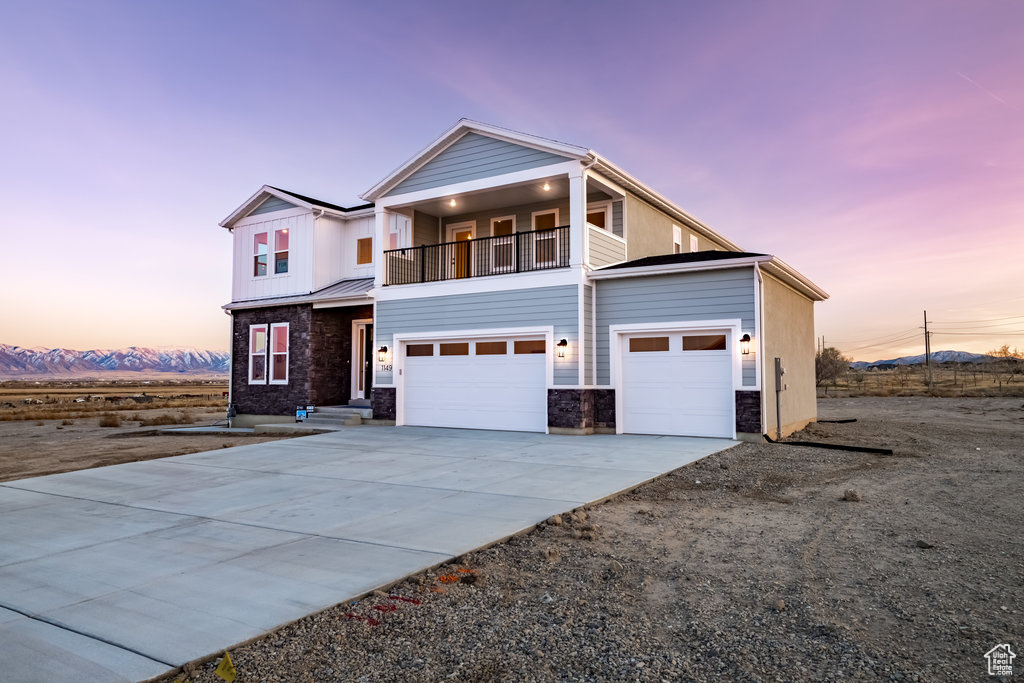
[{"x1": 0, "y1": 427, "x2": 734, "y2": 682}]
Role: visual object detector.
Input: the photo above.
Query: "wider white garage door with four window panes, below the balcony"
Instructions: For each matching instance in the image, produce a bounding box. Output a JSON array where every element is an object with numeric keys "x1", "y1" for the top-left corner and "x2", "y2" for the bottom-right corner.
[{"x1": 399, "y1": 338, "x2": 548, "y2": 432}]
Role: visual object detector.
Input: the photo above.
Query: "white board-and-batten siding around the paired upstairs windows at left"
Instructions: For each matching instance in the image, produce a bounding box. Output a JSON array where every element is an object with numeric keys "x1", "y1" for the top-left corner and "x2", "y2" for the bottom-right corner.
[{"x1": 231, "y1": 205, "x2": 313, "y2": 301}]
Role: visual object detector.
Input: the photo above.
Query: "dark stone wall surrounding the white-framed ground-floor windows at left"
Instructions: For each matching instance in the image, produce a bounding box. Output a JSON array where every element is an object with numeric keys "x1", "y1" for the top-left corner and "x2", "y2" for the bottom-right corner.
[{"x1": 231, "y1": 304, "x2": 312, "y2": 415}]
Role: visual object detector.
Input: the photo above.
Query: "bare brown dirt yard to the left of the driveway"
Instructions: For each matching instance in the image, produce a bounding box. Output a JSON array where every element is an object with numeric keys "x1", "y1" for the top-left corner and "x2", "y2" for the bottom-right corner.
[{"x1": 0, "y1": 409, "x2": 292, "y2": 481}]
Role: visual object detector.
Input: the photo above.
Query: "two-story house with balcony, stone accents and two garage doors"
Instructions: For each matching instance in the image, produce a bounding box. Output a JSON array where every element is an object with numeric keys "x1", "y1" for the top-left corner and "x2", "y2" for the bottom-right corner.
[{"x1": 221, "y1": 120, "x2": 827, "y2": 439}]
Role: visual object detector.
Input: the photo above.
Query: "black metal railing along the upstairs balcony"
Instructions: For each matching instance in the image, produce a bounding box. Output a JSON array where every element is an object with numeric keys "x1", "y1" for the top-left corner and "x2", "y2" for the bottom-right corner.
[{"x1": 384, "y1": 225, "x2": 569, "y2": 285}]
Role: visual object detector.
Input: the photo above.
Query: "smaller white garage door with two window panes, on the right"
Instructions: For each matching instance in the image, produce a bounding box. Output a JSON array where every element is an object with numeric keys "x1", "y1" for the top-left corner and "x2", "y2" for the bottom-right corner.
[{"x1": 620, "y1": 331, "x2": 735, "y2": 438}]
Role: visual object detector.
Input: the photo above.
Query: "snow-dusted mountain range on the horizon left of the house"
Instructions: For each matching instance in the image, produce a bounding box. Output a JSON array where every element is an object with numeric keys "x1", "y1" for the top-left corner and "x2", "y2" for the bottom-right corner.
[{"x1": 0, "y1": 344, "x2": 230, "y2": 379}]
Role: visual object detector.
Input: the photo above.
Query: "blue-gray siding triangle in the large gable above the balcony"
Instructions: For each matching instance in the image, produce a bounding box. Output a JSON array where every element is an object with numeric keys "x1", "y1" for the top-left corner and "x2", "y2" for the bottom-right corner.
[{"x1": 387, "y1": 133, "x2": 567, "y2": 195}]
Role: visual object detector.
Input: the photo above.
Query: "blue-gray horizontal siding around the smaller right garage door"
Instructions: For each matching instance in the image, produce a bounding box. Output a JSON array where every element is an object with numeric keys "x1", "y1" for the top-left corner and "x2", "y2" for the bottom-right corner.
[{"x1": 596, "y1": 268, "x2": 757, "y2": 386}]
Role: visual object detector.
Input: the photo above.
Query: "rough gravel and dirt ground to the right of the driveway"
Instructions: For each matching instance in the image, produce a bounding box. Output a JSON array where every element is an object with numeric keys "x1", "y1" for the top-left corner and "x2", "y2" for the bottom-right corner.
[{"x1": 172, "y1": 398, "x2": 1024, "y2": 683}]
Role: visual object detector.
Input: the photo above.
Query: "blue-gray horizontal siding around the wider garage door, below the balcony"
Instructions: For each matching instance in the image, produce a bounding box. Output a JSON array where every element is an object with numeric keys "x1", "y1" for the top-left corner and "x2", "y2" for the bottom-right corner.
[{"x1": 374, "y1": 285, "x2": 580, "y2": 385}]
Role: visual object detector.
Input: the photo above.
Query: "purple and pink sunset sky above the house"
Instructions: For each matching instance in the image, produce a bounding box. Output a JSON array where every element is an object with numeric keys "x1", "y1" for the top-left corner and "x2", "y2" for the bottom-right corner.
[{"x1": 0, "y1": 0, "x2": 1024, "y2": 360}]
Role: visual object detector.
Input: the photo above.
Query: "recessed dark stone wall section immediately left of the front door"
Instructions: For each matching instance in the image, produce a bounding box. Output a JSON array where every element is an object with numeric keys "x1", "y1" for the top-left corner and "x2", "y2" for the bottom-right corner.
[{"x1": 309, "y1": 305, "x2": 374, "y2": 405}]
